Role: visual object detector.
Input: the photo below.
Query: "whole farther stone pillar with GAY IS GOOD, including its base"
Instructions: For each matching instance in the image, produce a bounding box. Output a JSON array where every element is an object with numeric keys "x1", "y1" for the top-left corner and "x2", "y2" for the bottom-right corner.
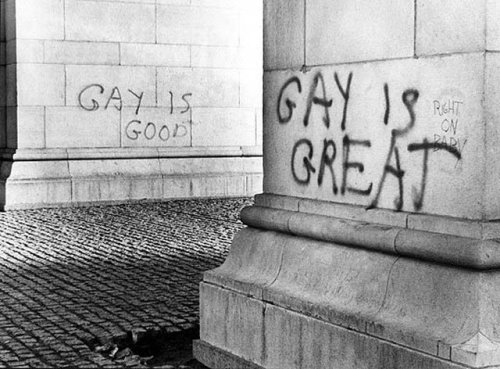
[{"x1": 0, "y1": 0, "x2": 262, "y2": 208}]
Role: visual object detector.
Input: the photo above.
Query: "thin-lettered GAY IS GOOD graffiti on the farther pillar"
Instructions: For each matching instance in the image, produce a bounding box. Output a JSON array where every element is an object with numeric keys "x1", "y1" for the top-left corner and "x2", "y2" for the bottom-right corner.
[{"x1": 78, "y1": 83, "x2": 192, "y2": 144}]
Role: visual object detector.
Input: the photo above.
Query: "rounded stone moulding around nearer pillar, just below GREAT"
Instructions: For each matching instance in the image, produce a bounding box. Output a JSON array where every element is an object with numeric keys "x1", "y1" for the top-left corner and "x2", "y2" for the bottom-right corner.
[{"x1": 250, "y1": 196, "x2": 500, "y2": 269}]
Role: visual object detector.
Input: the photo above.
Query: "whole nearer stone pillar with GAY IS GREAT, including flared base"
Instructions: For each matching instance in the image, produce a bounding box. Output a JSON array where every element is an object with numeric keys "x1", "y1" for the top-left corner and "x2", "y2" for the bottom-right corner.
[{"x1": 195, "y1": 0, "x2": 500, "y2": 369}]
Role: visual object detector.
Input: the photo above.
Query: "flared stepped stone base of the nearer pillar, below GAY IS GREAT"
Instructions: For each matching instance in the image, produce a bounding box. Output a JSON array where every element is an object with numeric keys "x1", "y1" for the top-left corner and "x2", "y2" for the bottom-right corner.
[{"x1": 195, "y1": 196, "x2": 500, "y2": 369}]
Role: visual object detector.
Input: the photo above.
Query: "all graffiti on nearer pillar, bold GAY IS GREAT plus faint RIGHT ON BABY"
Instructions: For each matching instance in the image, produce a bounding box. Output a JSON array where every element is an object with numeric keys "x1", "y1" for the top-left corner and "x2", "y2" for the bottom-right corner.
[{"x1": 276, "y1": 71, "x2": 466, "y2": 211}]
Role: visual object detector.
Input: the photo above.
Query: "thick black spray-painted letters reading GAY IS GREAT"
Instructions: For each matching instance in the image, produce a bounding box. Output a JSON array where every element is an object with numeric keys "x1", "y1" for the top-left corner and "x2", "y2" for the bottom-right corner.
[{"x1": 277, "y1": 73, "x2": 467, "y2": 211}]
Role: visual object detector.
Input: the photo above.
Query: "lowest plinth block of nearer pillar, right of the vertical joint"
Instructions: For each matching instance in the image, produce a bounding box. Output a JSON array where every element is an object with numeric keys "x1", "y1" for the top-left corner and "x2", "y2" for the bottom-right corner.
[{"x1": 263, "y1": 305, "x2": 466, "y2": 369}]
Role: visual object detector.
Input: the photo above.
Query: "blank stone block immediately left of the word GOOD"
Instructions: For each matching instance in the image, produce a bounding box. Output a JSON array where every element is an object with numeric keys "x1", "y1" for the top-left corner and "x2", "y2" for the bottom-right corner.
[{"x1": 46, "y1": 107, "x2": 120, "y2": 148}]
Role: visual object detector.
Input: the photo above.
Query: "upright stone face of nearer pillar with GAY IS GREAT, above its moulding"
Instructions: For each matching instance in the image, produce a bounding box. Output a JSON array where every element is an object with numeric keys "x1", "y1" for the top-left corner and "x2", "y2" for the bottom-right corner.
[{"x1": 264, "y1": 0, "x2": 500, "y2": 219}]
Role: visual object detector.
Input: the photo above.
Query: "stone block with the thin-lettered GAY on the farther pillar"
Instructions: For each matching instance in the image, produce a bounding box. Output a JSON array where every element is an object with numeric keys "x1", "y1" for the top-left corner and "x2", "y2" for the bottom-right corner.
[{"x1": 66, "y1": 65, "x2": 156, "y2": 107}]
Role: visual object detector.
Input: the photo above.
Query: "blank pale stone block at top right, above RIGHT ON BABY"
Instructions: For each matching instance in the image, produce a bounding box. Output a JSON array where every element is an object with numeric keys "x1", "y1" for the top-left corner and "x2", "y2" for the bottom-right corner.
[{"x1": 416, "y1": 0, "x2": 486, "y2": 55}]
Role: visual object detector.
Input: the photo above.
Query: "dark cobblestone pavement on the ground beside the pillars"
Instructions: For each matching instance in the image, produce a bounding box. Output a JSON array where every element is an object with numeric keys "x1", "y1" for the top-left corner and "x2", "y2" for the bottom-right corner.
[{"x1": 0, "y1": 199, "x2": 251, "y2": 368}]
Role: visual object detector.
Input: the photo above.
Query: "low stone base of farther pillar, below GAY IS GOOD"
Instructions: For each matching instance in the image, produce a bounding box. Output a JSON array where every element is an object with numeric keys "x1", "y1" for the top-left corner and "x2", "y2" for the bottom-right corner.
[{"x1": 0, "y1": 150, "x2": 262, "y2": 210}]
